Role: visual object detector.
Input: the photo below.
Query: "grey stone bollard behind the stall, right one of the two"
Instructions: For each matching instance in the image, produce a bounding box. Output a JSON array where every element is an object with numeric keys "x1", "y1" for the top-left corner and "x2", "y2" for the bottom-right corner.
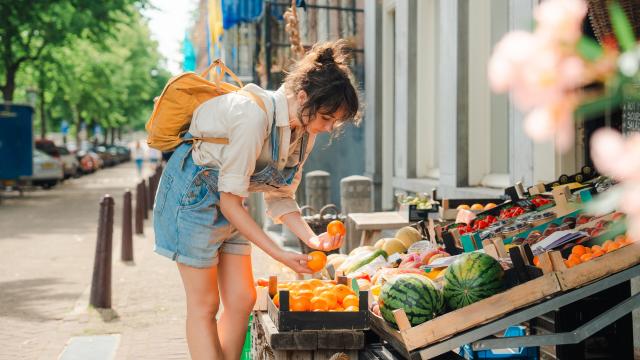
[{"x1": 340, "y1": 175, "x2": 373, "y2": 254}]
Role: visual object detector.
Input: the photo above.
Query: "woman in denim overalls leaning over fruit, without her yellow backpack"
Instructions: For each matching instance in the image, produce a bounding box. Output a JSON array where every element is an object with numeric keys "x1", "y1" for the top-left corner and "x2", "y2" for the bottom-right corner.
[{"x1": 154, "y1": 40, "x2": 360, "y2": 360}]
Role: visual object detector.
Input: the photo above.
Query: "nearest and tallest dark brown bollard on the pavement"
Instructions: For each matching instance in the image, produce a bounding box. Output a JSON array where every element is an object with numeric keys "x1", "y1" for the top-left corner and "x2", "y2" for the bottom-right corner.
[{"x1": 89, "y1": 195, "x2": 114, "y2": 309}]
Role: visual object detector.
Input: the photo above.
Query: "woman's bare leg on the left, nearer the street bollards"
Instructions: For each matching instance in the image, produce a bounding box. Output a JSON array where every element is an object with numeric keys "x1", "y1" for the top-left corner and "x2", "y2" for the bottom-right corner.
[{"x1": 178, "y1": 263, "x2": 222, "y2": 360}]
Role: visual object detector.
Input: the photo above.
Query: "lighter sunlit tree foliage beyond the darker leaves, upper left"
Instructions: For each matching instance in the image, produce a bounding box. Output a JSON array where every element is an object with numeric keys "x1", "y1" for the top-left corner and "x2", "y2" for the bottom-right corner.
[{"x1": 0, "y1": 0, "x2": 170, "y2": 137}]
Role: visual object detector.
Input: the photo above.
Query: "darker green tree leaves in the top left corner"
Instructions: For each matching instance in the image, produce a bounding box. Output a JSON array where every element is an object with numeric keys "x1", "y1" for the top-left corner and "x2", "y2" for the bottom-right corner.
[{"x1": 0, "y1": 0, "x2": 146, "y2": 101}]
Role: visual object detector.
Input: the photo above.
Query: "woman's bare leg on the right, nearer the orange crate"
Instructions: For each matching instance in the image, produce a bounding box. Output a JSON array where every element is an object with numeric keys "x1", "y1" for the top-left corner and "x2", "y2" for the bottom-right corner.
[{"x1": 218, "y1": 253, "x2": 256, "y2": 360}]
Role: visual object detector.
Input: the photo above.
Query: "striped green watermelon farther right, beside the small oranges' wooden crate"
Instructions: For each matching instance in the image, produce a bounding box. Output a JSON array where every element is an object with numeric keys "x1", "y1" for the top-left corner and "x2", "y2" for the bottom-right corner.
[{"x1": 442, "y1": 253, "x2": 504, "y2": 310}]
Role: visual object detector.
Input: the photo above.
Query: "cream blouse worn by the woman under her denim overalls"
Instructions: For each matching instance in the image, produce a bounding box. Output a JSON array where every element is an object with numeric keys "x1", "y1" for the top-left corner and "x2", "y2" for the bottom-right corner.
[{"x1": 189, "y1": 84, "x2": 315, "y2": 222}]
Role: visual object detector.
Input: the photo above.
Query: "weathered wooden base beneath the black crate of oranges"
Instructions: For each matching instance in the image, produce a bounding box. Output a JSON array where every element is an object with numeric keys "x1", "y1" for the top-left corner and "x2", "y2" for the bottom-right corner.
[{"x1": 251, "y1": 311, "x2": 364, "y2": 360}]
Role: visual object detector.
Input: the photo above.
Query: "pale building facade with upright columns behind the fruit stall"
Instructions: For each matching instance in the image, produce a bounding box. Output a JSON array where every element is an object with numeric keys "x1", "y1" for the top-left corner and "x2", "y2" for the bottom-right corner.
[{"x1": 364, "y1": 0, "x2": 584, "y2": 209}]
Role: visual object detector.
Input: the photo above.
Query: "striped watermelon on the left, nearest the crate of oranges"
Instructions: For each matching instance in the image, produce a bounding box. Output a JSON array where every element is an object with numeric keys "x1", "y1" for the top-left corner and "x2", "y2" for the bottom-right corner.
[{"x1": 378, "y1": 274, "x2": 444, "y2": 326}]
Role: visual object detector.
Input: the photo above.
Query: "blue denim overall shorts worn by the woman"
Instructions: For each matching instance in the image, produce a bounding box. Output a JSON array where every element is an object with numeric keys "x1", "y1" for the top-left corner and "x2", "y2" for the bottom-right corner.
[{"x1": 153, "y1": 97, "x2": 308, "y2": 268}]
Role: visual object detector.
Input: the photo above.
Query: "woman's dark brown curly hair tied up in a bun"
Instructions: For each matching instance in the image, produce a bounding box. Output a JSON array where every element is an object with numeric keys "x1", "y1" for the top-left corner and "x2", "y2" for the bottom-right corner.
[{"x1": 284, "y1": 39, "x2": 362, "y2": 128}]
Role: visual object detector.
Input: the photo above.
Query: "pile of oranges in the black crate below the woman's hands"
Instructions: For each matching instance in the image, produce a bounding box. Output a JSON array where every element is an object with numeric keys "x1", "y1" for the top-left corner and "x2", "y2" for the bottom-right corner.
[{"x1": 273, "y1": 279, "x2": 358, "y2": 311}]
